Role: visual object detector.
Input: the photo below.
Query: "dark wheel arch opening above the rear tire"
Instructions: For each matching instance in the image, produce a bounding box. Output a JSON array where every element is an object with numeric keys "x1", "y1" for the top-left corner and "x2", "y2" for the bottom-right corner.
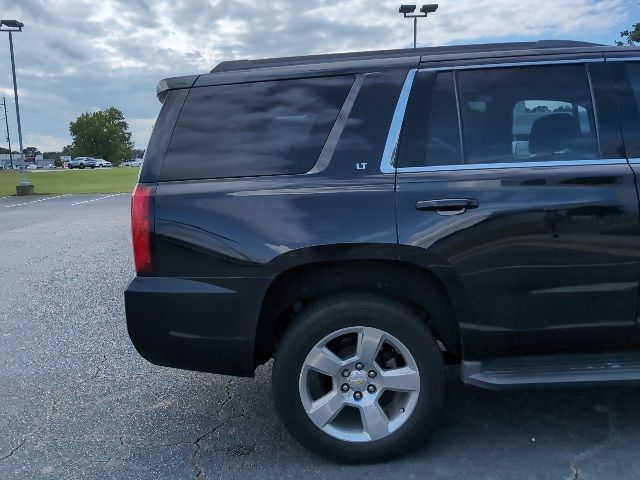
[{"x1": 255, "y1": 259, "x2": 462, "y2": 366}]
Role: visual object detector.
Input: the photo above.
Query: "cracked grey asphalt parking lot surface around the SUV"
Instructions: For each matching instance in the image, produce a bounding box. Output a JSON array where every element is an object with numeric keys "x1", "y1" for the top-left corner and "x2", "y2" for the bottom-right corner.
[{"x1": 0, "y1": 194, "x2": 640, "y2": 480}]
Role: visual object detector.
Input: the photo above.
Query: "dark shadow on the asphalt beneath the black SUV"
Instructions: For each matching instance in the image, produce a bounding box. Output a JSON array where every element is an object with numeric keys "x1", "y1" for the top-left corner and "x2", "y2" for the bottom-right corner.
[{"x1": 190, "y1": 365, "x2": 640, "y2": 479}]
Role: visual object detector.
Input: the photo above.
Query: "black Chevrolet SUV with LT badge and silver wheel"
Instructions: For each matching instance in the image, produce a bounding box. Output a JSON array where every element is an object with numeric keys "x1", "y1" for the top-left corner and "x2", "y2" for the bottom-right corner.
[{"x1": 125, "y1": 41, "x2": 640, "y2": 462}]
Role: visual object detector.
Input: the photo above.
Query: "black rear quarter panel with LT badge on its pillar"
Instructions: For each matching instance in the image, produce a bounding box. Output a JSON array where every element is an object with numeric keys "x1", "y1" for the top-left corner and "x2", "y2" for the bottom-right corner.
[{"x1": 154, "y1": 69, "x2": 407, "y2": 278}]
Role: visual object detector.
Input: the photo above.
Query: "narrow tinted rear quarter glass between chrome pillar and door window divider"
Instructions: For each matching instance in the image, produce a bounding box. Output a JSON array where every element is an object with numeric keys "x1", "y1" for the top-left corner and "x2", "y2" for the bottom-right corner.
[{"x1": 397, "y1": 72, "x2": 462, "y2": 168}]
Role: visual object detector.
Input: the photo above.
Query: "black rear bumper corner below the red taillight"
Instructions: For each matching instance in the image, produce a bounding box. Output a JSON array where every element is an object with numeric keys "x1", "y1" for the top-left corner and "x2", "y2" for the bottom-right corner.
[{"x1": 124, "y1": 277, "x2": 266, "y2": 376}]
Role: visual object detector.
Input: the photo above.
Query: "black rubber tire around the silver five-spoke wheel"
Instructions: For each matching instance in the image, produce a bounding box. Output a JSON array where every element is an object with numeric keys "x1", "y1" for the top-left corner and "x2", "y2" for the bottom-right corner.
[{"x1": 272, "y1": 293, "x2": 445, "y2": 463}]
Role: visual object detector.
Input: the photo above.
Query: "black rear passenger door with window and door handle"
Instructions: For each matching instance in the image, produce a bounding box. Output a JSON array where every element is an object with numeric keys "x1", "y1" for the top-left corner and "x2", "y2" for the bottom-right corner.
[{"x1": 382, "y1": 57, "x2": 640, "y2": 358}]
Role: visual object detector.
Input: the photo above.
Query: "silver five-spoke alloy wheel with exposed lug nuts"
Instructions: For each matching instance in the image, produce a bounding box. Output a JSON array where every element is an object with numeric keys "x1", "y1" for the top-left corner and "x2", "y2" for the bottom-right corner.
[{"x1": 299, "y1": 326, "x2": 420, "y2": 442}]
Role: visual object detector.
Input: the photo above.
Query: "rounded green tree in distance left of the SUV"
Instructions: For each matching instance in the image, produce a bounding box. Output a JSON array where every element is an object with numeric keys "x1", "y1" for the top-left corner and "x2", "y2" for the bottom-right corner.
[{"x1": 68, "y1": 107, "x2": 133, "y2": 165}]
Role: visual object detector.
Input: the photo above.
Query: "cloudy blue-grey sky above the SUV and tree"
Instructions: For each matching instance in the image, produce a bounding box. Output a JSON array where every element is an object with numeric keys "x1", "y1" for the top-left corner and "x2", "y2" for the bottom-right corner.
[{"x1": 0, "y1": 0, "x2": 640, "y2": 151}]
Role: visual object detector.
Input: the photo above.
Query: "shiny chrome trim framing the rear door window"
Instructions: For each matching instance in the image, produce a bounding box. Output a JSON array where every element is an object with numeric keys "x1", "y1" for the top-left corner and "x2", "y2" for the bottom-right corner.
[{"x1": 380, "y1": 56, "x2": 608, "y2": 173}]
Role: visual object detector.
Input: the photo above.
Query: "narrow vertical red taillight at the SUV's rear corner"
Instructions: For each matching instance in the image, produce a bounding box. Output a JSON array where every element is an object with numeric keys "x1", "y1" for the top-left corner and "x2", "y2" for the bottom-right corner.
[{"x1": 131, "y1": 185, "x2": 153, "y2": 275}]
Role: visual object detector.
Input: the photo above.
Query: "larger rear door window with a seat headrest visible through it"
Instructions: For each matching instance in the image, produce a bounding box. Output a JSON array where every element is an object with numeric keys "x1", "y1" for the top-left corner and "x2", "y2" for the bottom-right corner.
[{"x1": 457, "y1": 65, "x2": 599, "y2": 163}]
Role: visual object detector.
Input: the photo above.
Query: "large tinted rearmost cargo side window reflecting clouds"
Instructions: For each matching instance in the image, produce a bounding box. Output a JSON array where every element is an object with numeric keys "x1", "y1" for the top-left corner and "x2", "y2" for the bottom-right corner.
[{"x1": 161, "y1": 76, "x2": 354, "y2": 180}]
